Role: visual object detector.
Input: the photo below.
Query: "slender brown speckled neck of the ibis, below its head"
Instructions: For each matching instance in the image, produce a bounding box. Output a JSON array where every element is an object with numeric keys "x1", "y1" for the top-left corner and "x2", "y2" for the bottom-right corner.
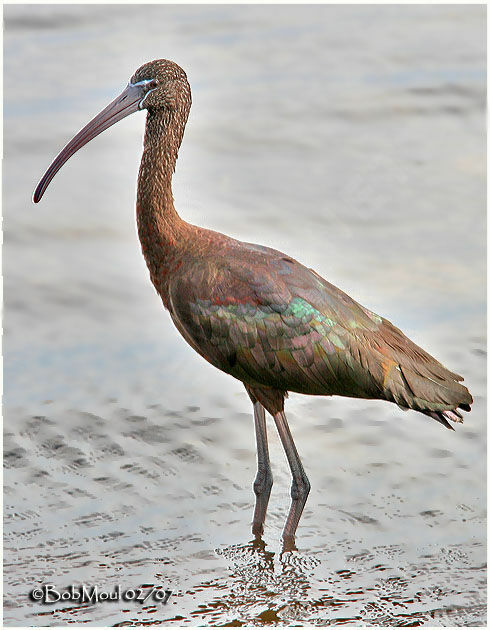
[{"x1": 136, "y1": 112, "x2": 192, "y2": 303}]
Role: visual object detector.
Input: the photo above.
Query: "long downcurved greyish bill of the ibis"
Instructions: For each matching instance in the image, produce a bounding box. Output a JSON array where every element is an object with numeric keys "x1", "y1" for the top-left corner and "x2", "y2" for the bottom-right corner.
[{"x1": 33, "y1": 81, "x2": 148, "y2": 203}]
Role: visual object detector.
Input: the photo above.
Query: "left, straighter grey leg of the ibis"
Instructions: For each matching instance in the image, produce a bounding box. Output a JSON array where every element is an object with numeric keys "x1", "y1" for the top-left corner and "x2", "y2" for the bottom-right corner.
[{"x1": 252, "y1": 401, "x2": 272, "y2": 536}]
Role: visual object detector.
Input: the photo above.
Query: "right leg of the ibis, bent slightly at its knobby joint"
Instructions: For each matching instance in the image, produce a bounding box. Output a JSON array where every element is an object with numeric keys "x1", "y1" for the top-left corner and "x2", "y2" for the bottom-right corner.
[{"x1": 274, "y1": 411, "x2": 310, "y2": 542}]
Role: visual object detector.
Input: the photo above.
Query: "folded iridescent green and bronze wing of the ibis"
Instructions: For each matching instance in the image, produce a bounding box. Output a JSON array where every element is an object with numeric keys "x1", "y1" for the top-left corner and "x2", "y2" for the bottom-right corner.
[{"x1": 170, "y1": 244, "x2": 471, "y2": 410}]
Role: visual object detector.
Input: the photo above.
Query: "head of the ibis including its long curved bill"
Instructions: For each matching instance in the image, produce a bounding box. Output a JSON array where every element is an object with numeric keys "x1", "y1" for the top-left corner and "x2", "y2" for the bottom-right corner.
[{"x1": 33, "y1": 59, "x2": 191, "y2": 203}]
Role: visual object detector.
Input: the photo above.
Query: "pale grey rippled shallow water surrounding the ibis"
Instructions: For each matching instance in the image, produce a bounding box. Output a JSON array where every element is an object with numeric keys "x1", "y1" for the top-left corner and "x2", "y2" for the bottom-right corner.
[{"x1": 3, "y1": 5, "x2": 486, "y2": 626}]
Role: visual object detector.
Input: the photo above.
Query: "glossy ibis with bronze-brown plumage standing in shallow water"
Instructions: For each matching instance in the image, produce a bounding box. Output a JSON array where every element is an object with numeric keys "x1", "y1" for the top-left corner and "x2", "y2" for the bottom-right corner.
[{"x1": 34, "y1": 59, "x2": 473, "y2": 541}]
